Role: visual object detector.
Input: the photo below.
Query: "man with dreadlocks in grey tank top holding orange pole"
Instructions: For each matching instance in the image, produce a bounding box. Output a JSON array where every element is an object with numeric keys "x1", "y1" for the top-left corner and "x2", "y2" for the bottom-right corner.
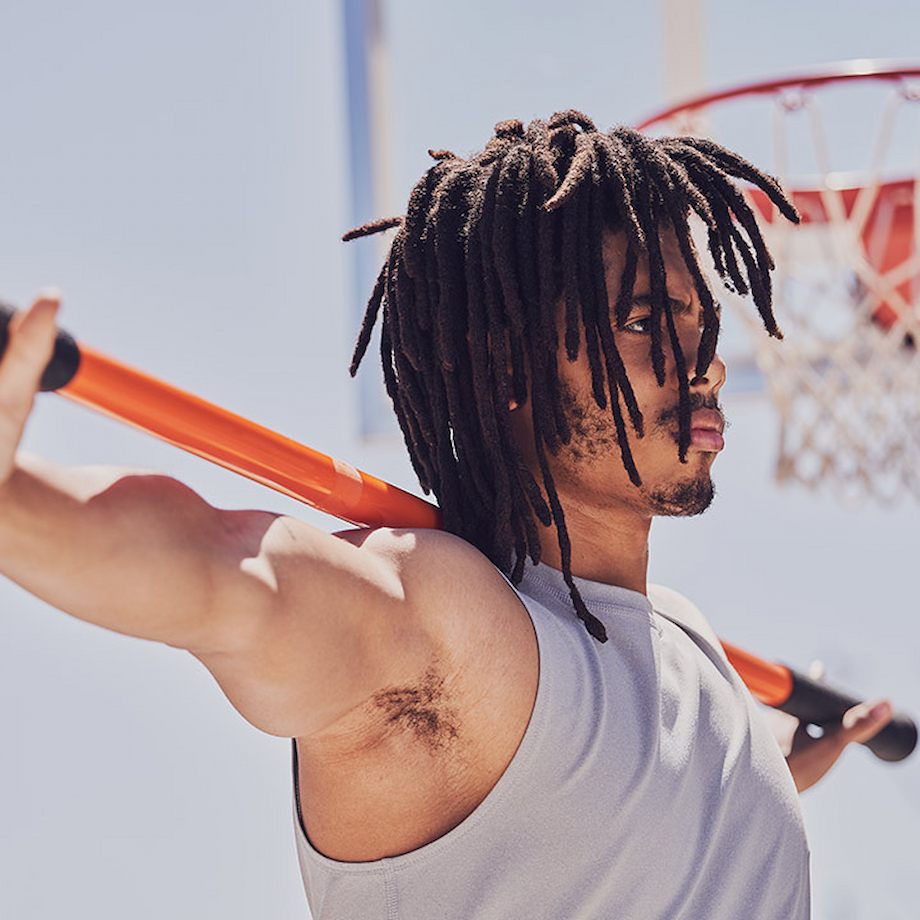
[{"x1": 0, "y1": 111, "x2": 887, "y2": 920}]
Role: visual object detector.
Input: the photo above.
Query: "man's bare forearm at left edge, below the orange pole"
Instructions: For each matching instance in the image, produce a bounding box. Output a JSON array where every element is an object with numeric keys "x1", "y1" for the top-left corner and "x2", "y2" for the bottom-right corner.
[{"x1": 0, "y1": 452, "x2": 228, "y2": 648}]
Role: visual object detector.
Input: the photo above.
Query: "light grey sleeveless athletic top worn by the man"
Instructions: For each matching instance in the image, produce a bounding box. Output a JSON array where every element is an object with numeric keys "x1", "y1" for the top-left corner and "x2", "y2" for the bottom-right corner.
[{"x1": 292, "y1": 563, "x2": 811, "y2": 920}]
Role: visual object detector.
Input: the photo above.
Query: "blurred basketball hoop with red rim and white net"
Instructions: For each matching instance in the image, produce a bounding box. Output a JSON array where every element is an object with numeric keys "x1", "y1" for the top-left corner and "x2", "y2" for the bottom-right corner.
[{"x1": 637, "y1": 61, "x2": 920, "y2": 502}]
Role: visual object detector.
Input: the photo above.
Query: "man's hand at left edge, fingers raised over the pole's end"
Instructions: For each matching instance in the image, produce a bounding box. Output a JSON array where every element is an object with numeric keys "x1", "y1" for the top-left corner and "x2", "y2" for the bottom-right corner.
[{"x1": 0, "y1": 288, "x2": 61, "y2": 485}]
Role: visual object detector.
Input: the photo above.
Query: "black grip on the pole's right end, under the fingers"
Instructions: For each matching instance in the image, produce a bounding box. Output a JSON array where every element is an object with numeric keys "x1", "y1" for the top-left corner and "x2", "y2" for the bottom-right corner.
[{"x1": 776, "y1": 665, "x2": 917, "y2": 761}]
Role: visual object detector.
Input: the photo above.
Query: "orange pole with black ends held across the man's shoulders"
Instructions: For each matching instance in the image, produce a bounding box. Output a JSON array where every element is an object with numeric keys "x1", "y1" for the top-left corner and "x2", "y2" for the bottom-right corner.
[{"x1": 0, "y1": 302, "x2": 917, "y2": 761}]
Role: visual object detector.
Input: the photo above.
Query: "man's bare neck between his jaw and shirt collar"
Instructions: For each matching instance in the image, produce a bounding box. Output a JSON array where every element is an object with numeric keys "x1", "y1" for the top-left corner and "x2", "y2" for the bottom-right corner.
[{"x1": 538, "y1": 495, "x2": 652, "y2": 594}]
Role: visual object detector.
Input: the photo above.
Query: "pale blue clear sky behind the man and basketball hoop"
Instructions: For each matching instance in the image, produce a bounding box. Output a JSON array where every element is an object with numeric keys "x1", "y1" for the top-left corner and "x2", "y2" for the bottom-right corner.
[{"x1": 0, "y1": 0, "x2": 920, "y2": 920}]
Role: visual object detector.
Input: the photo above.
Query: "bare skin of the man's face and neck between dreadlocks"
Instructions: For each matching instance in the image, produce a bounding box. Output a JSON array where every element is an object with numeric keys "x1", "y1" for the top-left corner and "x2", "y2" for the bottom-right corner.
[{"x1": 511, "y1": 230, "x2": 726, "y2": 594}]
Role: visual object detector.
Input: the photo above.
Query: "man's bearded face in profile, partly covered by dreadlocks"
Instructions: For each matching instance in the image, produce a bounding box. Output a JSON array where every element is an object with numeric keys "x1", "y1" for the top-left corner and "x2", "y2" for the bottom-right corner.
[{"x1": 512, "y1": 230, "x2": 725, "y2": 516}]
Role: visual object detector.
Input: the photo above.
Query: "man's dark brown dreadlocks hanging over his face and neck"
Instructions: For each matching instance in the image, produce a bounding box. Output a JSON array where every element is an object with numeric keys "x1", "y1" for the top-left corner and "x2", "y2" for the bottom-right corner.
[{"x1": 342, "y1": 110, "x2": 798, "y2": 642}]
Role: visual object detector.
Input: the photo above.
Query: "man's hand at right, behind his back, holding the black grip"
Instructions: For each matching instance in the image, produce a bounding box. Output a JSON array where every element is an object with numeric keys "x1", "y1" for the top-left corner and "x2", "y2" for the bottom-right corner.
[{"x1": 773, "y1": 662, "x2": 892, "y2": 792}]
